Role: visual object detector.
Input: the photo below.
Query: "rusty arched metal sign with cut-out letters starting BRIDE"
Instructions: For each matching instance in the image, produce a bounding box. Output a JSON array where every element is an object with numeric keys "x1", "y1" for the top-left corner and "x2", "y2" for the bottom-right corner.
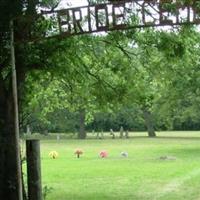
[{"x1": 42, "y1": 0, "x2": 200, "y2": 37}]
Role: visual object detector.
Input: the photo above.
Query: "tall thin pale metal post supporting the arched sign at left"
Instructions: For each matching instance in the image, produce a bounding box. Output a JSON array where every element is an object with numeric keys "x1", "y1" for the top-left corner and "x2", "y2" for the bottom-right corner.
[{"x1": 10, "y1": 20, "x2": 23, "y2": 200}]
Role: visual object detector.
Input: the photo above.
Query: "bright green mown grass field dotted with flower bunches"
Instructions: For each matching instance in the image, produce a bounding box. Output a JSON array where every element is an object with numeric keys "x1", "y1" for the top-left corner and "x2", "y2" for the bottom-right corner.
[{"x1": 25, "y1": 132, "x2": 200, "y2": 200}]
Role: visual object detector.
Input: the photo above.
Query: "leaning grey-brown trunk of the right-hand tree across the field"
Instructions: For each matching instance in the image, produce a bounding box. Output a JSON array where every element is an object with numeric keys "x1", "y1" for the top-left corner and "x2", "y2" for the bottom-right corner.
[{"x1": 143, "y1": 108, "x2": 156, "y2": 137}]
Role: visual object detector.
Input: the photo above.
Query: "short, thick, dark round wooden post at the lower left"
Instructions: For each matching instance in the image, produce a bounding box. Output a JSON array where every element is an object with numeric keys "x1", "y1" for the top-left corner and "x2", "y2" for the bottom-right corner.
[{"x1": 26, "y1": 140, "x2": 42, "y2": 200}]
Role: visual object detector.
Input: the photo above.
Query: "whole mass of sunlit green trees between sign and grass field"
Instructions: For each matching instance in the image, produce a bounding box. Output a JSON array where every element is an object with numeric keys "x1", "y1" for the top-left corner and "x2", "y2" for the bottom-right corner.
[{"x1": 21, "y1": 26, "x2": 200, "y2": 138}]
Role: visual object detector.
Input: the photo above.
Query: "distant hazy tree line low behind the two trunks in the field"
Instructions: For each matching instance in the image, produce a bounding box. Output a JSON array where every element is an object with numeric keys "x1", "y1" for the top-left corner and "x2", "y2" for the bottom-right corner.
[{"x1": 21, "y1": 102, "x2": 200, "y2": 134}]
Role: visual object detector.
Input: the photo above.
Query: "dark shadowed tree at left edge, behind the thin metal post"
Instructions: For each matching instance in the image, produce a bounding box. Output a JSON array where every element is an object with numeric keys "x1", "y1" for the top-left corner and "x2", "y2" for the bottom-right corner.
[{"x1": 0, "y1": 0, "x2": 65, "y2": 200}]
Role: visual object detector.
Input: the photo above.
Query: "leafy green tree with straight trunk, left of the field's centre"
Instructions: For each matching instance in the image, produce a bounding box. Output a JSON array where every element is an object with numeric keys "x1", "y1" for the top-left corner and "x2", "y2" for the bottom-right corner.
[{"x1": 22, "y1": 33, "x2": 129, "y2": 139}]
